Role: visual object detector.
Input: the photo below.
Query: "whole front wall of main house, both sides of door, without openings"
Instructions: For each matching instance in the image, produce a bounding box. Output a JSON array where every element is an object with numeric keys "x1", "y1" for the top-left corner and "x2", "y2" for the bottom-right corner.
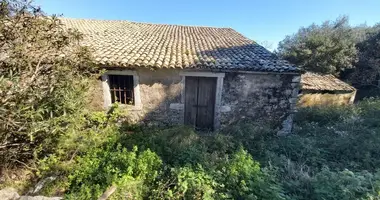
[{"x1": 89, "y1": 69, "x2": 299, "y2": 131}]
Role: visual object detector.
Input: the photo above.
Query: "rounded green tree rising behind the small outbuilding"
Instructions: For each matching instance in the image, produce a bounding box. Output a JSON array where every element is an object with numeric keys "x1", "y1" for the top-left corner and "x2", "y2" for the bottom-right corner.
[{"x1": 277, "y1": 17, "x2": 357, "y2": 75}]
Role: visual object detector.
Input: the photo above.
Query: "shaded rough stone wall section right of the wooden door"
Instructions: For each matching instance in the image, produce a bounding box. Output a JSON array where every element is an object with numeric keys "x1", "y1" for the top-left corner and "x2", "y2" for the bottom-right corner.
[{"x1": 221, "y1": 73, "x2": 300, "y2": 129}]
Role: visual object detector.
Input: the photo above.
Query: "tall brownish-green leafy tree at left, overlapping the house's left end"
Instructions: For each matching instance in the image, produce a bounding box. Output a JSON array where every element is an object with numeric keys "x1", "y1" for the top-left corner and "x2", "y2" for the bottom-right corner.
[{"x1": 0, "y1": 0, "x2": 93, "y2": 164}]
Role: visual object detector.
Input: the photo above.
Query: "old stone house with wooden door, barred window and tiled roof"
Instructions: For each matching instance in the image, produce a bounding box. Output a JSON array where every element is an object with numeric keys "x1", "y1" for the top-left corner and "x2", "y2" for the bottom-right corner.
[{"x1": 61, "y1": 18, "x2": 300, "y2": 129}]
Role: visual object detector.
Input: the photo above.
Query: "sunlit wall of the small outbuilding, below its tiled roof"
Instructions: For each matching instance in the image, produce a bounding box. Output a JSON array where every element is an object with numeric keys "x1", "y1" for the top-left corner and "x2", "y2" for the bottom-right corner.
[{"x1": 297, "y1": 91, "x2": 356, "y2": 107}]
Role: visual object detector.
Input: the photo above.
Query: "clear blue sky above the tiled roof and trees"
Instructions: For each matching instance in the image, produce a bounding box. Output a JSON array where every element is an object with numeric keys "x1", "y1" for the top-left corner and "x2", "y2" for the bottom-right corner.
[{"x1": 35, "y1": 0, "x2": 380, "y2": 49}]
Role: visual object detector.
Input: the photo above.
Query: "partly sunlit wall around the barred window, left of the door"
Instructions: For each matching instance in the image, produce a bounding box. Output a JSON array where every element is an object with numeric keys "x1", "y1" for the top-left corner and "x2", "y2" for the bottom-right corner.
[{"x1": 90, "y1": 69, "x2": 183, "y2": 125}]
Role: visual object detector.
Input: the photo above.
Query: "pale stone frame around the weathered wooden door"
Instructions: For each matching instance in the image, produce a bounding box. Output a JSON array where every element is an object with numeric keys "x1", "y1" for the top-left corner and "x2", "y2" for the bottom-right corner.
[{"x1": 180, "y1": 71, "x2": 225, "y2": 130}]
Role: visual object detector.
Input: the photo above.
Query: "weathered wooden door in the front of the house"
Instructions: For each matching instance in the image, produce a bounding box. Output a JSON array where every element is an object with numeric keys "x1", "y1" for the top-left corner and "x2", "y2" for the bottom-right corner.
[{"x1": 185, "y1": 76, "x2": 216, "y2": 130}]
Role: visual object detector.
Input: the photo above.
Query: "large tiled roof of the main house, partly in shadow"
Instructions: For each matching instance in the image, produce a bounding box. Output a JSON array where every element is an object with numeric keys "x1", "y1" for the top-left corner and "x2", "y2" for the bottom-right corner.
[{"x1": 61, "y1": 18, "x2": 298, "y2": 72}]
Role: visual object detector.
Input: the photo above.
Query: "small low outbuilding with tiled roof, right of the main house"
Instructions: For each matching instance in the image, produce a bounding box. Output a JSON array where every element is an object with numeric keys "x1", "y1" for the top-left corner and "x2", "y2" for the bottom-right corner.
[{"x1": 298, "y1": 72, "x2": 356, "y2": 107}]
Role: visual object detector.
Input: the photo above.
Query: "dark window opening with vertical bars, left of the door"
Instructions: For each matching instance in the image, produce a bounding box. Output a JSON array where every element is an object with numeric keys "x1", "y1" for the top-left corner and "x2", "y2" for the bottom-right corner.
[{"x1": 109, "y1": 75, "x2": 135, "y2": 105}]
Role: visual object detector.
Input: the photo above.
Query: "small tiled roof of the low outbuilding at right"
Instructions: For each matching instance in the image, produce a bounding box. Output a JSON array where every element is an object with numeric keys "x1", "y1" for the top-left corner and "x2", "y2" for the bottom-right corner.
[{"x1": 301, "y1": 72, "x2": 356, "y2": 91}]
